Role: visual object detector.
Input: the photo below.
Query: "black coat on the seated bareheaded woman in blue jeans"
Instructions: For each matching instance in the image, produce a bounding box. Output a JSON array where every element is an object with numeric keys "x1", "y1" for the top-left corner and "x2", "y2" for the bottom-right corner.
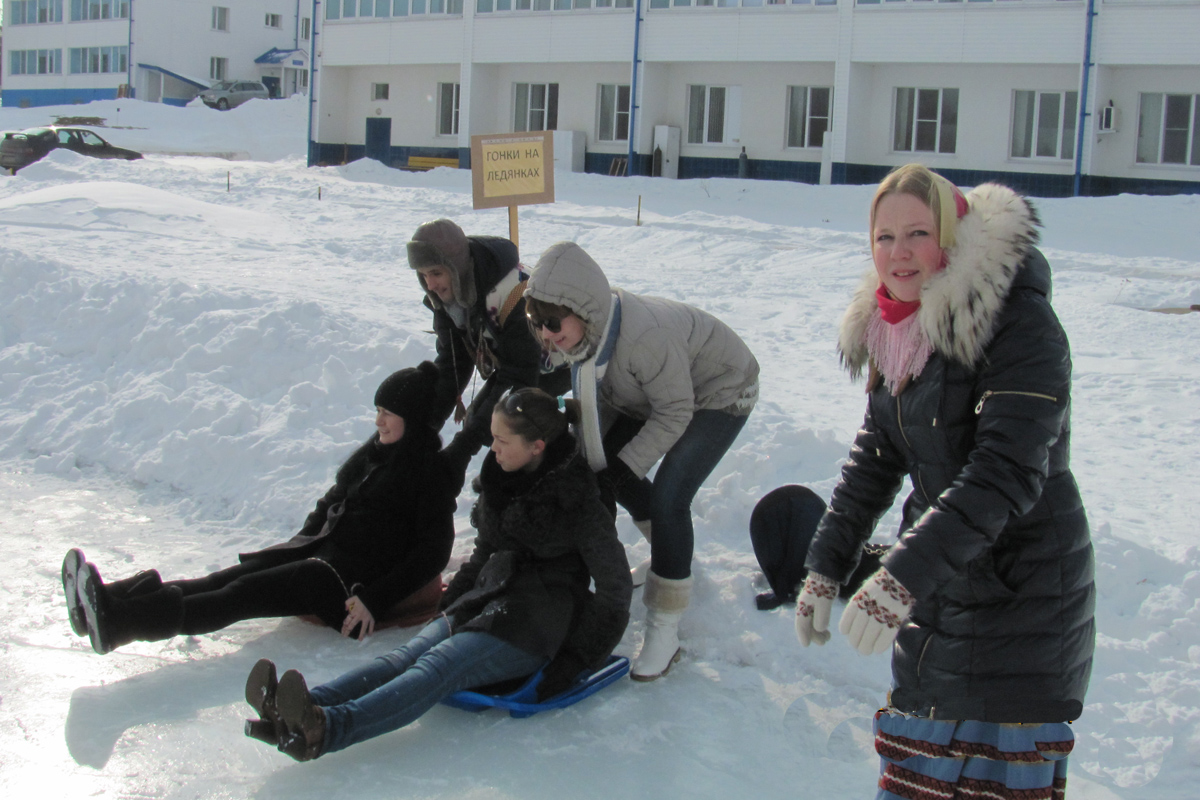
[{"x1": 442, "y1": 434, "x2": 634, "y2": 669}]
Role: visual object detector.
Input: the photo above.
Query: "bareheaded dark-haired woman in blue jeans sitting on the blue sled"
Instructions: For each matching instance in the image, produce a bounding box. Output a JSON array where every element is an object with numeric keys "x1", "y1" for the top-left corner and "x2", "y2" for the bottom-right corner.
[{"x1": 246, "y1": 389, "x2": 632, "y2": 760}]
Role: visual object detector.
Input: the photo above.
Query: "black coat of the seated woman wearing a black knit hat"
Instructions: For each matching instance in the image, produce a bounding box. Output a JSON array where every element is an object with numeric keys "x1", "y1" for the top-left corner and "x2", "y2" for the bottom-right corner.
[{"x1": 239, "y1": 427, "x2": 457, "y2": 619}]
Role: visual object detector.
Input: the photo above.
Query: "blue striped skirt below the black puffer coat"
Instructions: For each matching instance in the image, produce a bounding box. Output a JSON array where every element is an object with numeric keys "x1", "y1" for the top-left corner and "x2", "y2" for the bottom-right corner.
[{"x1": 875, "y1": 709, "x2": 1075, "y2": 800}]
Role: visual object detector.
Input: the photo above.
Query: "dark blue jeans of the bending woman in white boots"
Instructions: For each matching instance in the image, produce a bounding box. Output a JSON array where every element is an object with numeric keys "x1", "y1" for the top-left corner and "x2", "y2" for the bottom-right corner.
[{"x1": 605, "y1": 410, "x2": 748, "y2": 579}]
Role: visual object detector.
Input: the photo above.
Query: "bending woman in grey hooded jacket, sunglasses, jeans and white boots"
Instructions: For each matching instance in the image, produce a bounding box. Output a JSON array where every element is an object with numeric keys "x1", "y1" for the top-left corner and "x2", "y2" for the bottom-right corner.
[{"x1": 524, "y1": 242, "x2": 758, "y2": 680}]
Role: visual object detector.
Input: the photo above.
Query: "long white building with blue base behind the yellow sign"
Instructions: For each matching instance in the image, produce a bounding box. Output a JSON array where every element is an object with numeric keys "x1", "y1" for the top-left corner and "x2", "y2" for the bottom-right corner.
[{"x1": 310, "y1": 0, "x2": 1200, "y2": 196}]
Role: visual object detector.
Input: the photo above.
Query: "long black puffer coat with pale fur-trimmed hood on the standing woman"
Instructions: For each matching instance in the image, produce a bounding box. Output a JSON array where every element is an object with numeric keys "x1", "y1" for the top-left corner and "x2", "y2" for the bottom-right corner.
[{"x1": 805, "y1": 186, "x2": 1096, "y2": 722}]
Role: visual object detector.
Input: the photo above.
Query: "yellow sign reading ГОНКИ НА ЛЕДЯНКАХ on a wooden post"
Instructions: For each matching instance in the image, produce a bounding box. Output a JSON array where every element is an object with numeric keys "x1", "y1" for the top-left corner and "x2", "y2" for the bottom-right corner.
[{"x1": 470, "y1": 131, "x2": 554, "y2": 249}]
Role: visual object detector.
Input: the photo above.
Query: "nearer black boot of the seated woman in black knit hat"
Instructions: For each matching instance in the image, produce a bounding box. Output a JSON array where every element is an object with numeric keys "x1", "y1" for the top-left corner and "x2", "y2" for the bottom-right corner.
[{"x1": 78, "y1": 564, "x2": 184, "y2": 655}]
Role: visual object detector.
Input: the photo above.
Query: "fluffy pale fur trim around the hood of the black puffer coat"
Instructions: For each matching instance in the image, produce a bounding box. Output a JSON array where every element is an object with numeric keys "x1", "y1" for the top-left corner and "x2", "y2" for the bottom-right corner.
[{"x1": 838, "y1": 184, "x2": 1040, "y2": 378}]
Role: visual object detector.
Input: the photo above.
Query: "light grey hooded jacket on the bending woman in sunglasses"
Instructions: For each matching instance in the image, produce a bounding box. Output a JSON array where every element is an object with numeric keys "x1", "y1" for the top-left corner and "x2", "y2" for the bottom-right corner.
[{"x1": 526, "y1": 242, "x2": 758, "y2": 477}]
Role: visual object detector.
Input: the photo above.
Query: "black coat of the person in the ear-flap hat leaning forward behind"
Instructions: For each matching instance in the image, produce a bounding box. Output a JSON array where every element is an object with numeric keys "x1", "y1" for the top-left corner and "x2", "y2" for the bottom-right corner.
[{"x1": 425, "y1": 236, "x2": 570, "y2": 452}]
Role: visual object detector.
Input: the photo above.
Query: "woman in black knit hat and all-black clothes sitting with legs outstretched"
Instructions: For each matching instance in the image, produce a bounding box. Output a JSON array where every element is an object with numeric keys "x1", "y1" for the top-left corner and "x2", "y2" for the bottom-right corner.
[{"x1": 62, "y1": 361, "x2": 458, "y2": 654}]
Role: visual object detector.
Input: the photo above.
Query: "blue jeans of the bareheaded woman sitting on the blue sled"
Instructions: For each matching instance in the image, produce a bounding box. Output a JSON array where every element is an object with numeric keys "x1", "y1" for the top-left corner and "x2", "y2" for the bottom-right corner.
[{"x1": 310, "y1": 616, "x2": 546, "y2": 753}]
